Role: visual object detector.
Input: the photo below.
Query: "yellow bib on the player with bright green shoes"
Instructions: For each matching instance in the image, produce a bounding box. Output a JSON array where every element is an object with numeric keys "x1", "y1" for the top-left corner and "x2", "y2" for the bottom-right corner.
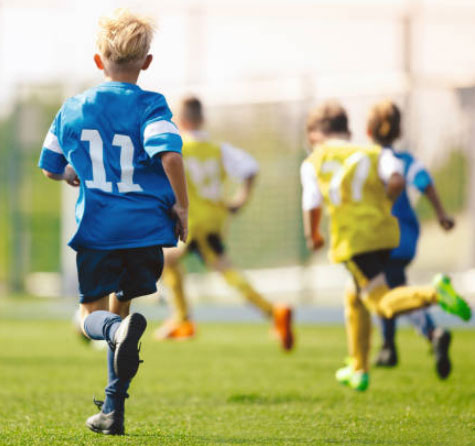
[{"x1": 307, "y1": 140, "x2": 399, "y2": 262}]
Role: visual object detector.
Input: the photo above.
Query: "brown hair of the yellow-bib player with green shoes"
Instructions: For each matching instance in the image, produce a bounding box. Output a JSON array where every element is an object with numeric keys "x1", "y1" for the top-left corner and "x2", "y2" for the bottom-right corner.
[{"x1": 307, "y1": 100, "x2": 350, "y2": 135}]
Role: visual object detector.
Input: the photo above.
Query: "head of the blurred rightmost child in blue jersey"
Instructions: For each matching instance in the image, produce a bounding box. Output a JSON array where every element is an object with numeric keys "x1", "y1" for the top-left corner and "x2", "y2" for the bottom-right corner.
[{"x1": 367, "y1": 99, "x2": 401, "y2": 146}]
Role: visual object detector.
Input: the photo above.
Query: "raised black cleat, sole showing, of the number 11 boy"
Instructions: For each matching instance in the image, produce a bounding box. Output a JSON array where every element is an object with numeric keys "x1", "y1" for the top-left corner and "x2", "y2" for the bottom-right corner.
[{"x1": 114, "y1": 313, "x2": 147, "y2": 381}]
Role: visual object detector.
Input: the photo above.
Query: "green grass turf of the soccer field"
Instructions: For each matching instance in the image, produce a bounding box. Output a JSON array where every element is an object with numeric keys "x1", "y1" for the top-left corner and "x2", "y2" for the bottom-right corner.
[{"x1": 0, "y1": 319, "x2": 475, "y2": 446}]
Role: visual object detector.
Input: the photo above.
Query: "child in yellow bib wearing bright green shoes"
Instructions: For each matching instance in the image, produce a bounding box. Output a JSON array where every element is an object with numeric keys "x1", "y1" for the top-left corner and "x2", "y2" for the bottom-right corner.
[{"x1": 301, "y1": 102, "x2": 471, "y2": 390}]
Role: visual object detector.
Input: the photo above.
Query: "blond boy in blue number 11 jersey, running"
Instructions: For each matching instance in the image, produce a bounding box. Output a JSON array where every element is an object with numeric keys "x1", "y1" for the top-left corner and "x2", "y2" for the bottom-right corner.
[{"x1": 39, "y1": 10, "x2": 188, "y2": 435}]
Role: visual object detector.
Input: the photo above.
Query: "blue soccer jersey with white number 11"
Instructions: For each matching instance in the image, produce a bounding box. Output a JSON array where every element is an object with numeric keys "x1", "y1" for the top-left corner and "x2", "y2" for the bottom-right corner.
[{"x1": 39, "y1": 82, "x2": 182, "y2": 250}]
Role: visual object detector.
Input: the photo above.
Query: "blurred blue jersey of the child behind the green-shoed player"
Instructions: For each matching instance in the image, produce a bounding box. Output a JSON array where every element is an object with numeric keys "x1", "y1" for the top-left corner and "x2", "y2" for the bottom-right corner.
[{"x1": 391, "y1": 152, "x2": 432, "y2": 260}]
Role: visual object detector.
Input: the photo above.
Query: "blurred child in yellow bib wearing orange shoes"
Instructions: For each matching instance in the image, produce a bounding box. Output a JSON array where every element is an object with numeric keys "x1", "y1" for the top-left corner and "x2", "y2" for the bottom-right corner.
[{"x1": 155, "y1": 97, "x2": 293, "y2": 350}]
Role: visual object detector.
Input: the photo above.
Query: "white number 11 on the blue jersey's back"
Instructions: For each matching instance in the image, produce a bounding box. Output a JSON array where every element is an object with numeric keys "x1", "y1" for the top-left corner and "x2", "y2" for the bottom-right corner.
[{"x1": 81, "y1": 129, "x2": 142, "y2": 193}]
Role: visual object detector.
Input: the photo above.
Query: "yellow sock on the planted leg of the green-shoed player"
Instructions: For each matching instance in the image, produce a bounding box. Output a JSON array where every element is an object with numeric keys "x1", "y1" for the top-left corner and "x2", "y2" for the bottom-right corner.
[{"x1": 345, "y1": 288, "x2": 371, "y2": 372}]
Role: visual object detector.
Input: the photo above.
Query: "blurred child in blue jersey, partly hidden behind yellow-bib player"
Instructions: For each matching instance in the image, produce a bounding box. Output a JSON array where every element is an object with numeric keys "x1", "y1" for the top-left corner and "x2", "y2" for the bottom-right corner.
[{"x1": 367, "y1": 100, "x2": 454, "y2": 379}]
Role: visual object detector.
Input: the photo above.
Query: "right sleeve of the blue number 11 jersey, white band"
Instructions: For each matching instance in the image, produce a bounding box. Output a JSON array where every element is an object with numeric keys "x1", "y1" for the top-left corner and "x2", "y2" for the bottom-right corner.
[{"x1": 141, "y1": 95, "x2": 183, "y2": 158}]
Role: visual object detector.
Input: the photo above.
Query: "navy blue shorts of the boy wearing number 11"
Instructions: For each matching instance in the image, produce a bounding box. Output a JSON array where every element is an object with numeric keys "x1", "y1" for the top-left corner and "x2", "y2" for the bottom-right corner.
[{"x1": 76, "y1": 246, "x2": 163, "y2": 303}]
